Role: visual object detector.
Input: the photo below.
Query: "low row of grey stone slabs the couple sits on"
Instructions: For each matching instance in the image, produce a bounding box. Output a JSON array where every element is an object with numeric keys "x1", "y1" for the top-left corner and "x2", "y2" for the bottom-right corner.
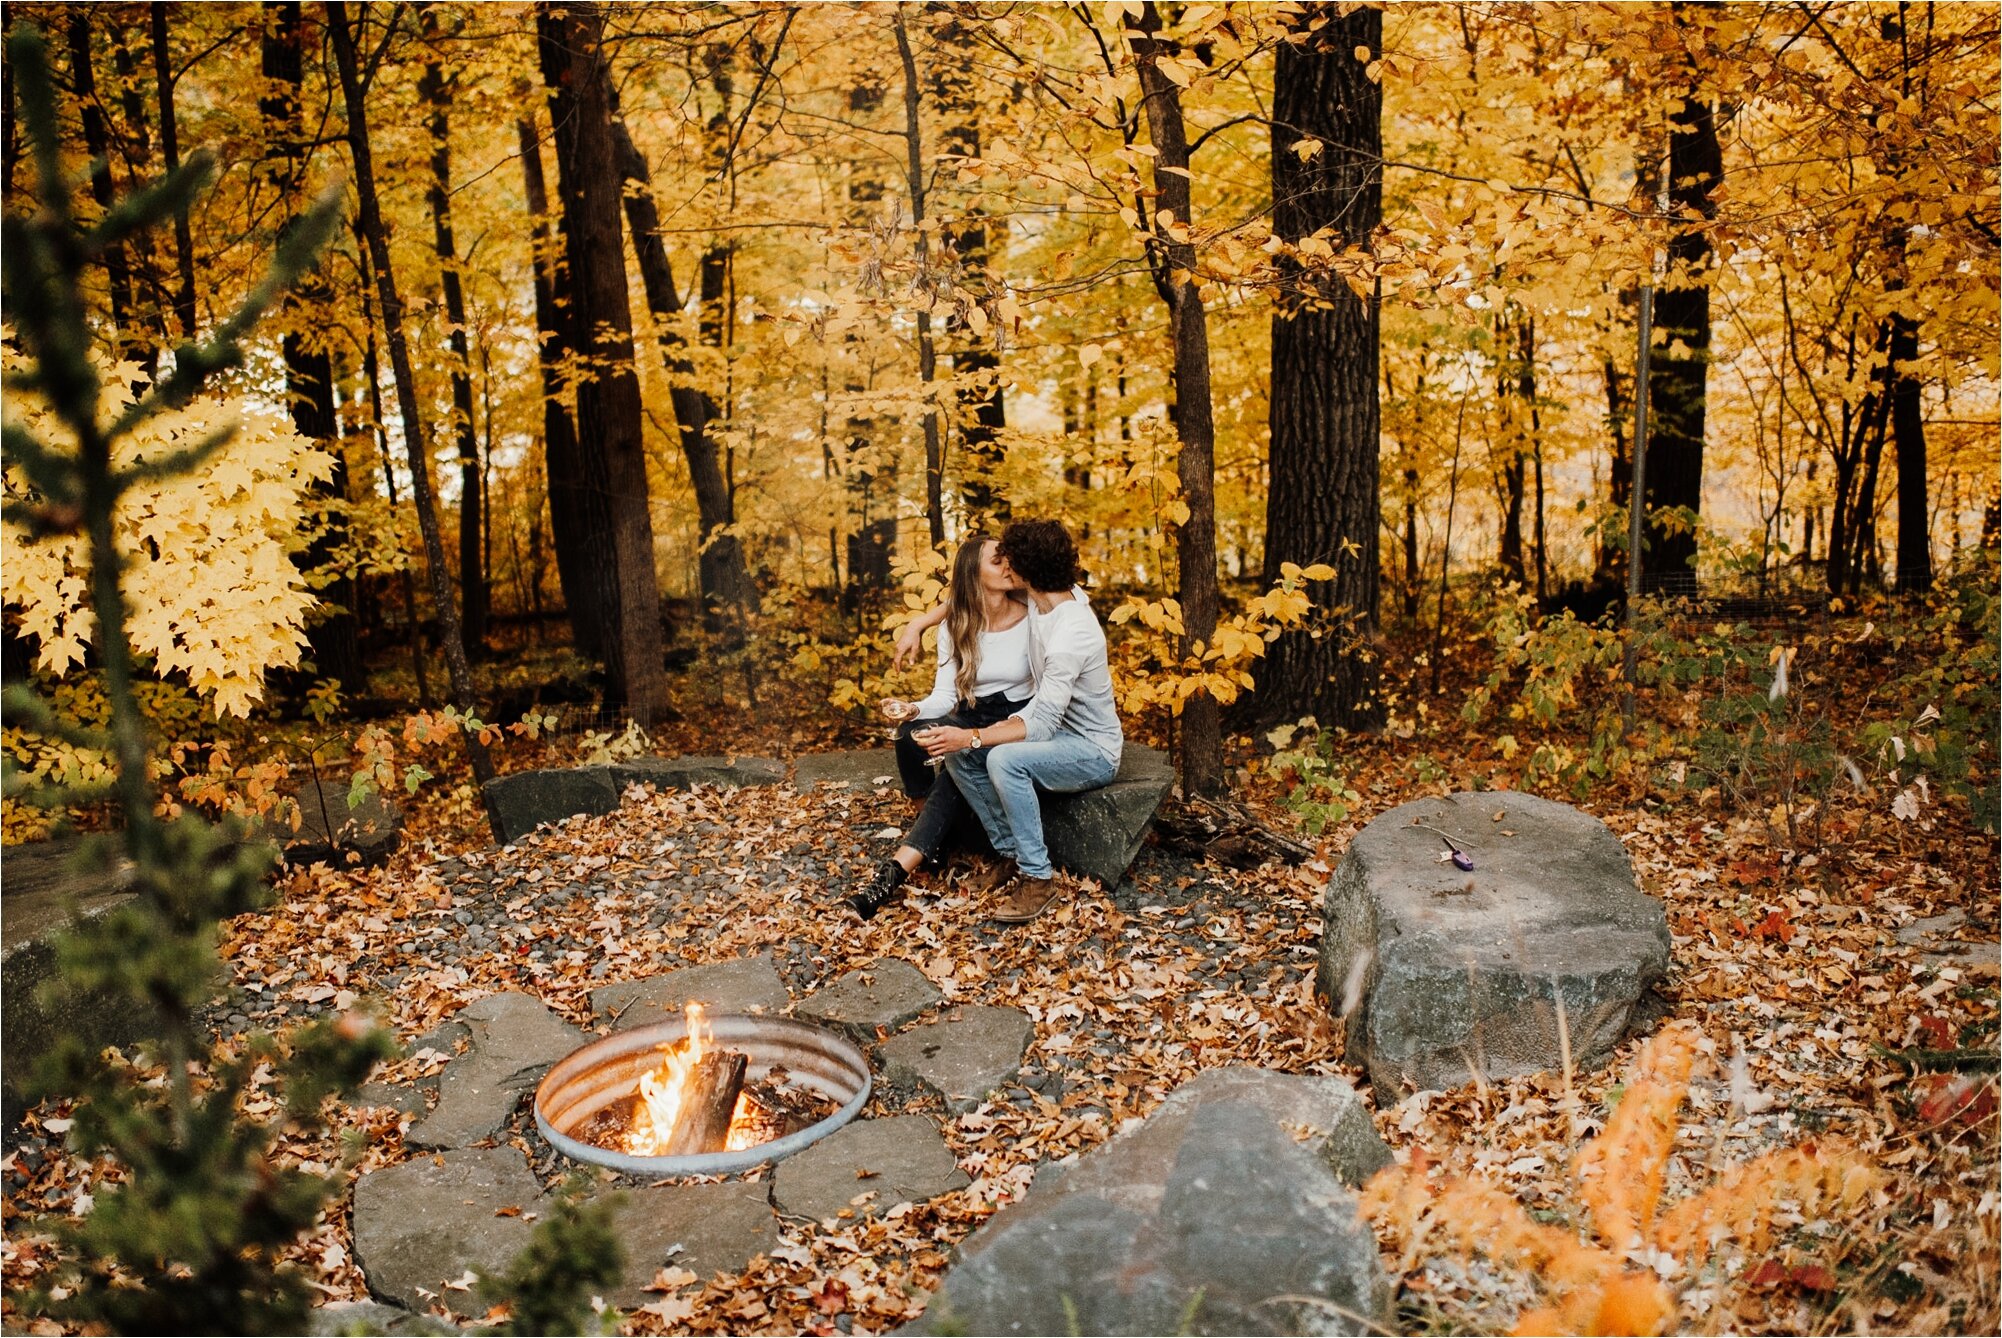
[{"x1": 484, "y1": 743, "x2": 1175, "y2": 887}]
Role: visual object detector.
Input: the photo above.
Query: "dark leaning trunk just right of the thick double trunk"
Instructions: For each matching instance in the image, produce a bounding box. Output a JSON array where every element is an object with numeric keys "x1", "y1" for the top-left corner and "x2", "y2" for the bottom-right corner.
[{"x1": 613, "y1": 122, "x2": 753, "y2": 627}]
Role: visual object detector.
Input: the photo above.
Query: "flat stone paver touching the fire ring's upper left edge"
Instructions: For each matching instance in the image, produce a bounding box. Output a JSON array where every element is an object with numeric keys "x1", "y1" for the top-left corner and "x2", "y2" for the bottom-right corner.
[{"x1": 406, "y1": 993, "x2": 587, "y2": 1148}]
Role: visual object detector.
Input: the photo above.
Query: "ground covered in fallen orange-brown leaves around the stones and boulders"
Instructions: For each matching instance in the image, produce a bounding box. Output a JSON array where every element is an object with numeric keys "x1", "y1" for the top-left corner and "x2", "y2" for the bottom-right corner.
[{"x1": 0, "y1": 681, "x2": 2002, "y2": 1332}]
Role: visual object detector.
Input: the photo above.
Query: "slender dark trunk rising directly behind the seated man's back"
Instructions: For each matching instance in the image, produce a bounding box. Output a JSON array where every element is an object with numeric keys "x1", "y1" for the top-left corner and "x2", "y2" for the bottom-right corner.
[{"x1": 1133, "y1": 0, "x2": 1223, "y2": 795}]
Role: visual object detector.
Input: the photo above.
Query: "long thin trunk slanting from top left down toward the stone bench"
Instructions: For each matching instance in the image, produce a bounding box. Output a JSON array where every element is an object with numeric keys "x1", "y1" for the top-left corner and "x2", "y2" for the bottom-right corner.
[{"x1": 326, "y1": 0, "x2": 503, "y2": 801}]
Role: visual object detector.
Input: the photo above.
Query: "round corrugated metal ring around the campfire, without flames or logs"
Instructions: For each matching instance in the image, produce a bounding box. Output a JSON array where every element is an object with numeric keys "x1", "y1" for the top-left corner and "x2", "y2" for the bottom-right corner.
[{"x1": 535, "y1": 1014, "x2": 871, "y2": 1176}]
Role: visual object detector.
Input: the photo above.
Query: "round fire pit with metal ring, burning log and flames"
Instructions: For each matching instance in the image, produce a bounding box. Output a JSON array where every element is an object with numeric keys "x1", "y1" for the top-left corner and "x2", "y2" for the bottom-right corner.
[{"x1": 535, "y1": 1004, "x2": 871, "y2": 1176}]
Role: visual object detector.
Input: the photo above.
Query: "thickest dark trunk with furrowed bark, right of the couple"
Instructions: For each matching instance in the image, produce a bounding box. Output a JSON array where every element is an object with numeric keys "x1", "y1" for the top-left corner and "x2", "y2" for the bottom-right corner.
[{"x1": 1253, "y1": 6, "x2": 1383, "y2": 729}]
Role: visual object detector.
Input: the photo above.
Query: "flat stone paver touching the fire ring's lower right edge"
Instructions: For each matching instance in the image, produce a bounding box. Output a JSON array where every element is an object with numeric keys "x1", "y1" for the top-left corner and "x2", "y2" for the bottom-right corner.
[{"x1": 771, "y1": 1116, "x2": 969, "y2": 1222}]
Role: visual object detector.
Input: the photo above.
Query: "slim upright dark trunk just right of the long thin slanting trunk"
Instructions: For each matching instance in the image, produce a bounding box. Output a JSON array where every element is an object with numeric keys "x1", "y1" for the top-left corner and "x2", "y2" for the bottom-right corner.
[{"x1": 416, "y1": 27, "x2": 490, "y2": 657}]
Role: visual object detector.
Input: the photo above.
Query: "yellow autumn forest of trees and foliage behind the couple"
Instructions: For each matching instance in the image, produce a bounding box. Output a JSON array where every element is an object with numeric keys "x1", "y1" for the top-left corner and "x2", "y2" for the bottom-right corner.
[{"x1": 0, "y1": 0, "x2": 2002, "y2": 1332}]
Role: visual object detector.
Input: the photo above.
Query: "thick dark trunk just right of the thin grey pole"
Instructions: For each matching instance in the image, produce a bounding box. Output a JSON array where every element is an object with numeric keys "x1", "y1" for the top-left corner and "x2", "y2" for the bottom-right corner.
[{"x1": 1642, "y1": 34, "x2": 1724, "y2": 595}]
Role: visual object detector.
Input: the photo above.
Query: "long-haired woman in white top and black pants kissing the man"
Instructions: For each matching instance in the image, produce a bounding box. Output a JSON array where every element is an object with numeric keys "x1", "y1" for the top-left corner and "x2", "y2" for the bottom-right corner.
[{"x1": 849, "y1": 535, "x2": 1033, "y2": 919}]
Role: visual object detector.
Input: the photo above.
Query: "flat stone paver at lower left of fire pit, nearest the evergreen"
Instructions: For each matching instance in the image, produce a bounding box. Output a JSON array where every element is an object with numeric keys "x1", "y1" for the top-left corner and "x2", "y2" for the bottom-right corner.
[{"x1": 352, "y1": 1148, "x2": 543, "y2": 1314}]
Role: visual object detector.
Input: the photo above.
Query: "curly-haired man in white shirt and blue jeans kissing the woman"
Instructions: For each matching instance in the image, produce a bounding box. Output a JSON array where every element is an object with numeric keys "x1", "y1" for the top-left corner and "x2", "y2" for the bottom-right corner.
[{"x1": 921, "y1": 521, "x2": 1125, "y2": 923}]
